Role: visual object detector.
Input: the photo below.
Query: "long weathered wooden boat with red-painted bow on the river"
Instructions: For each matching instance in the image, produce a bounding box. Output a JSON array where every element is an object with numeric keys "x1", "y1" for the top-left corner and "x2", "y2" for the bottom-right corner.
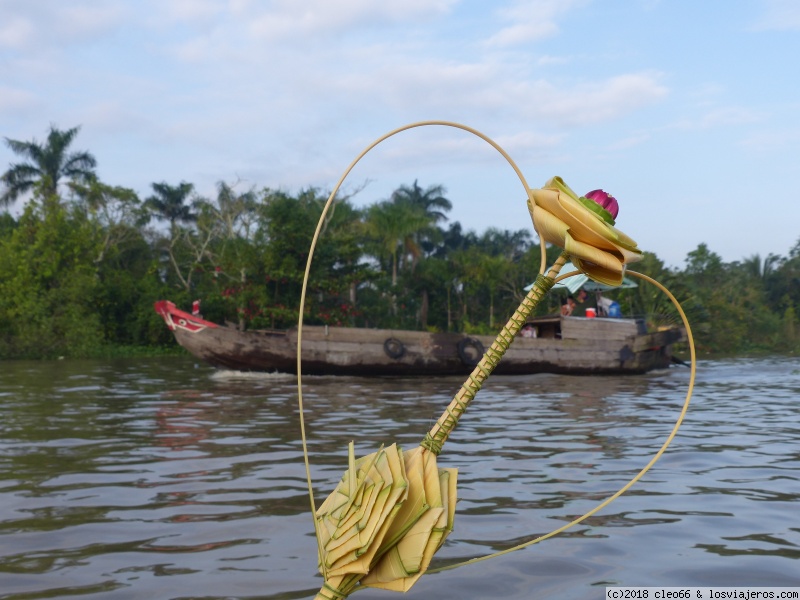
[{"x1": 155, "y1": 300, "x2": 683, "y2": 376}]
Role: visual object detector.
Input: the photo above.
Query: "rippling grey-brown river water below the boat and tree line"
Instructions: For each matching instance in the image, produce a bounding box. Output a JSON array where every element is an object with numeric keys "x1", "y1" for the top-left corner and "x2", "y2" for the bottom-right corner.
[{"x1": 0, "y1": 358, "x2": 800, "y2": 600}]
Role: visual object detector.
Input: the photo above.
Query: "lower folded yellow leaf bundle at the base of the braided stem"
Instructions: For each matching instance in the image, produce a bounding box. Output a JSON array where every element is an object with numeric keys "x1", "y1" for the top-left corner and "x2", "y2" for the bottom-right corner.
[{"x1": 316, "y1": 443, "x2": 456, "y2": 598}]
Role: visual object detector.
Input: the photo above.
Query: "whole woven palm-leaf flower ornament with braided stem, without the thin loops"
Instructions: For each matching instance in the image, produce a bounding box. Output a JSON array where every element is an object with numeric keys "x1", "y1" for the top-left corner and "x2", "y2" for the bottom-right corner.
[{"x1": 315, "y1": 172, "x2": 641, "y2": 600}]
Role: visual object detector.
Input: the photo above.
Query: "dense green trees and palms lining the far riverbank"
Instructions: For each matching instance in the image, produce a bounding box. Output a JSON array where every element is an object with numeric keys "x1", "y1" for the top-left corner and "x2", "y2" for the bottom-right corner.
[{"x1": 0, "y1": 127, "x2": 800, "y2": 358}]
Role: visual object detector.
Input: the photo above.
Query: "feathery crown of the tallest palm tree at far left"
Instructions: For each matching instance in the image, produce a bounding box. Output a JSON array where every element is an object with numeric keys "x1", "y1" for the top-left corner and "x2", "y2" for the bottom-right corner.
[{"x1": 0, "y1": 125, "x2": 97, "y2": 206}]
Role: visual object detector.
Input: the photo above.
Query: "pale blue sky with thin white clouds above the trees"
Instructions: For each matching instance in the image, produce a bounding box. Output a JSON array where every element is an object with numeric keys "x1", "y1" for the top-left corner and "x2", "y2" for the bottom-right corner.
[{"x1": 0, "y1": 0, "x2": 800, "y2": 268}]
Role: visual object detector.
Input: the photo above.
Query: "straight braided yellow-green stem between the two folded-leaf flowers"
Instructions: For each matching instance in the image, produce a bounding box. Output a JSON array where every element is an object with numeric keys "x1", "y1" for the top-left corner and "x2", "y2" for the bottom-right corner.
[{"x1": 420, "y1": 252, "x2": 568, "y2": 456}]
